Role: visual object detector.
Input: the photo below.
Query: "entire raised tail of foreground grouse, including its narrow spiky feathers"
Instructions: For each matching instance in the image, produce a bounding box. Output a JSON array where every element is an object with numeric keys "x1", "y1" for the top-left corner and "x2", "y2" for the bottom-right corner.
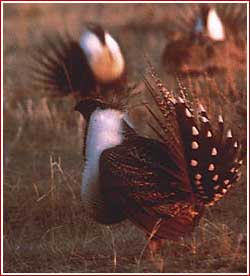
[{"x1": 145, "y1": 65, "x2": 243, "y2": 206}]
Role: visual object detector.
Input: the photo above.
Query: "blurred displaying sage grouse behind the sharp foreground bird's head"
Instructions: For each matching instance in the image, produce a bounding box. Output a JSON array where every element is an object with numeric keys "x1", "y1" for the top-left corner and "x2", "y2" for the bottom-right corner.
[{"x1": 33, "y1": 24, "x2": 126, "y2": 100}]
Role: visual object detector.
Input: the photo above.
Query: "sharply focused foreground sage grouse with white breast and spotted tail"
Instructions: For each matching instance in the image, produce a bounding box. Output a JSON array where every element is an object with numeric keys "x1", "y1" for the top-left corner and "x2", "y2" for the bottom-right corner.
[{"x1": 75, "y1": 73, "x2": 242, "y2": 250}]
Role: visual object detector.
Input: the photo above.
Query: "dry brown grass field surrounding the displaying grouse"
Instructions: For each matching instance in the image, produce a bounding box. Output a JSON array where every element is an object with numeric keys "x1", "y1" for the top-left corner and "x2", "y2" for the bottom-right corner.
[{"x1": 2, "y1": 3, "x2": 248, "y2": 273}]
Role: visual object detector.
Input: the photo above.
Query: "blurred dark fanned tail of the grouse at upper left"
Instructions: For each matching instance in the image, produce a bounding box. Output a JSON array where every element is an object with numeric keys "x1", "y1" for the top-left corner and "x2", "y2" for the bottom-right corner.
[{"x1": 31, "y1": 34, "x2": 95, "y2": 97}]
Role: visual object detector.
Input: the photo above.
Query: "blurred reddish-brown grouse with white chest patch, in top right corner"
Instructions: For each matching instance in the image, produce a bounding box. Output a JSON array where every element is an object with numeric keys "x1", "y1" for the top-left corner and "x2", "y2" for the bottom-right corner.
[{"x1": 162, "y1": 3, "x2": 247, "y2": 74}]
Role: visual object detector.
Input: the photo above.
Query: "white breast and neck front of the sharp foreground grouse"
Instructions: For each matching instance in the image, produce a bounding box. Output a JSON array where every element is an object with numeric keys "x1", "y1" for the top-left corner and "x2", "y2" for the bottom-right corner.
[{"x1": 82, "y1": 108, "x2": 124, "y2": 211}]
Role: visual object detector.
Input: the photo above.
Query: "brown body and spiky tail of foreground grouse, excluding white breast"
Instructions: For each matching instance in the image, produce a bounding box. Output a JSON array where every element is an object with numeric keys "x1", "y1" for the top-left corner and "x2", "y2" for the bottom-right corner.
[{"x1": 73, "y1": 72, "x2": 242, "y2": 242}]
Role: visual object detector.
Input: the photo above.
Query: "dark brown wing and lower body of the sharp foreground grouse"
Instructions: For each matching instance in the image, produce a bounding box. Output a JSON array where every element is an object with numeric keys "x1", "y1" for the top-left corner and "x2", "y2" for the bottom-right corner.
[{"x1": 100, "y1": 136, "x2": 202, "y2": 238}]
